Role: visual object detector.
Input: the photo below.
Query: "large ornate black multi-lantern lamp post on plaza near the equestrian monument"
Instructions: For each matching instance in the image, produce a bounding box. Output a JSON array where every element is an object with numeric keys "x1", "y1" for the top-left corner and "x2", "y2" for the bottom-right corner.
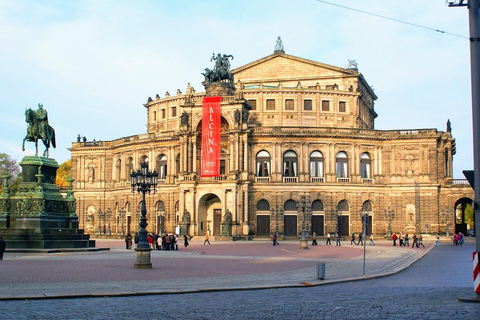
[{"x1": 130, "y1": 162, "x2": 158, "y2": 269}]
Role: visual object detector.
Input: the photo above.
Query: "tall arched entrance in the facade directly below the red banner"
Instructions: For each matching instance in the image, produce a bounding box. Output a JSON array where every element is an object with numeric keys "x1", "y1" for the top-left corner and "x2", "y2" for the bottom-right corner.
[{"x1": 198, "y1": 193, "x2": 223, "y2": 236}]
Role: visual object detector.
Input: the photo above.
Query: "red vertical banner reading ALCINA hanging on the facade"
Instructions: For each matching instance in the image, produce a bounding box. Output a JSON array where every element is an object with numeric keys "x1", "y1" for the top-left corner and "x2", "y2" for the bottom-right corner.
[{"x1": 200, "y1": 97, "x2": 222, "y2": 177}]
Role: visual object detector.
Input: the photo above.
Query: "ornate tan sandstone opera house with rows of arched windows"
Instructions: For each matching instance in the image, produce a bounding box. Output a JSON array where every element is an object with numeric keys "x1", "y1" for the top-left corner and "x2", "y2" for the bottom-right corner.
[{"x1": 70, "y1": 51, "x2": 473, "y2": 238}]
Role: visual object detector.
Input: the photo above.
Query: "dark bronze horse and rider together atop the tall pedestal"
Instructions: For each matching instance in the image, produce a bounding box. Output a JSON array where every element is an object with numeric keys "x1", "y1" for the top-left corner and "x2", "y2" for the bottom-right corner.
[{"x1": 22, "y1": 103, "x2": 56, "y2": 158}]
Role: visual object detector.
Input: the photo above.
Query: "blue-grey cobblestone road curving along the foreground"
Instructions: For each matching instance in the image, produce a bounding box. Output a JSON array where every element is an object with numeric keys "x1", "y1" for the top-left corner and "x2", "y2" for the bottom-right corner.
[{"x1": 0, "y1": 242, "x2": 480, "y2": 319}]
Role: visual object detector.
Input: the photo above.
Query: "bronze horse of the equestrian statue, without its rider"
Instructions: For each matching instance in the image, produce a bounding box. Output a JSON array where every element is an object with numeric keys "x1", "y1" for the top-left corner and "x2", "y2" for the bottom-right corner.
[{"x1": 22, "y1": 108, "x2": 57, "y2": 158}]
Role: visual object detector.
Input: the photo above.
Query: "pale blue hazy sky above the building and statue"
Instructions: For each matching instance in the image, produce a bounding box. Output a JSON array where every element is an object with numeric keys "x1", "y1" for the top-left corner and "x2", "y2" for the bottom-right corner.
[{"x1": 0, "y1": 0, "x2": 473, "y2": 178}]
